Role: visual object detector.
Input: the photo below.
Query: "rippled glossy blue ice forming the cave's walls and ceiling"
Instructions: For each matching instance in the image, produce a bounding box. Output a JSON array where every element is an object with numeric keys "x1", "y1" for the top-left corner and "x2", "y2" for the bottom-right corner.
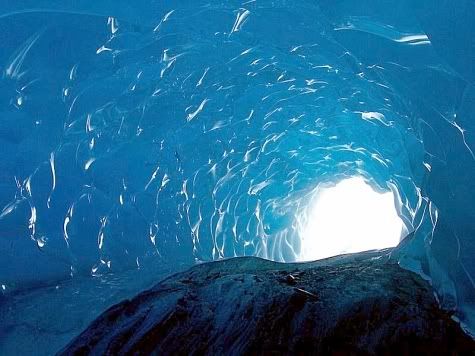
[{"x1": 0, "y1": 0, "x2": 475, "y2": 353}]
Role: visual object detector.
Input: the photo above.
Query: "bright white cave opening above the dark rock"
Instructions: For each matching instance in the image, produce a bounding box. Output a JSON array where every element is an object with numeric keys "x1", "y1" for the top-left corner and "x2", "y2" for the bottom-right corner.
[{"x1": 299, "y1": 177, "x2": 403, "y2": 261}]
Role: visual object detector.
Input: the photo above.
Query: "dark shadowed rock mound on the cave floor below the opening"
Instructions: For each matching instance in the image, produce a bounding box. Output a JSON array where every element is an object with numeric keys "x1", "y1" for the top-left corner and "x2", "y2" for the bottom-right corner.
[{"x1": 62, "y1": 253, "x2": 475, "y2": 355}]
